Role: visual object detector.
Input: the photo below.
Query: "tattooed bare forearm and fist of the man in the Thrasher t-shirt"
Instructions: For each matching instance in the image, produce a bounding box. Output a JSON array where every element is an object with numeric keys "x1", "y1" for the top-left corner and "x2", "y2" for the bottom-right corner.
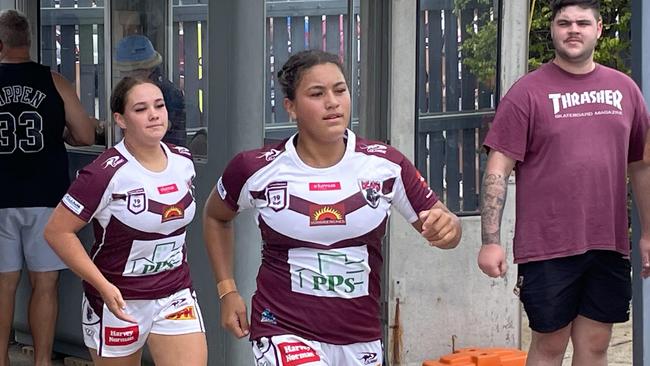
[{"x1": 478, "y1": 150, "x2": 515, "y2": 277}]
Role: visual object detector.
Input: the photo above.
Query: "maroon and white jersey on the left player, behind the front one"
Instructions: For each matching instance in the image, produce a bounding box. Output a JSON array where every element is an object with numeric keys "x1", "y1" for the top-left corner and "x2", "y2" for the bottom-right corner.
[{"x1": 61, "y1": 141, "x2": 196, "y2": 299}]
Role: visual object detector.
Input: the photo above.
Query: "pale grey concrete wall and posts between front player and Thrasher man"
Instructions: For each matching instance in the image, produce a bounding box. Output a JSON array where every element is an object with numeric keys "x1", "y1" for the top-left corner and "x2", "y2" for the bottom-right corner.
[{"x1": 386, "y1": 0, "x2": 528, "y2": 366}]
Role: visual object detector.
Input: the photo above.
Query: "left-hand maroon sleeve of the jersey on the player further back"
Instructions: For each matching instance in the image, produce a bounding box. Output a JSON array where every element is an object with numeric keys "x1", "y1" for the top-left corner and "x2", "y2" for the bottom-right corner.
[{"x1": 61, "y1": 167, "x2": 108, "y2": 222}]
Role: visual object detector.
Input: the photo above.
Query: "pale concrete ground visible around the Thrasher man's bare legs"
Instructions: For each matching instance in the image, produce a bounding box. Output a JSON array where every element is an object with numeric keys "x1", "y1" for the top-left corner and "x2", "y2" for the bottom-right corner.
[{"x1": 521, "y1": 312, "x2": 632, "y2": 366}]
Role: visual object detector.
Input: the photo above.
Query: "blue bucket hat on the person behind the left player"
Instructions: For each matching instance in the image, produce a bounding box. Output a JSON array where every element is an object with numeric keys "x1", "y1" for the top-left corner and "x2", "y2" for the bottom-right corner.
[{"x1": 115, "y1": 34, "x2": 162, "y2": 71}]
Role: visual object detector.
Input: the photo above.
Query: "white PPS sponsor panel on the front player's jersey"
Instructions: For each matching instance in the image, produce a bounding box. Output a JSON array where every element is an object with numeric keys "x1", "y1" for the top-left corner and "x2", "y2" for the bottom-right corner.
[{"x1": 288, "y1": 245, "x2": 370, "y2": 299}]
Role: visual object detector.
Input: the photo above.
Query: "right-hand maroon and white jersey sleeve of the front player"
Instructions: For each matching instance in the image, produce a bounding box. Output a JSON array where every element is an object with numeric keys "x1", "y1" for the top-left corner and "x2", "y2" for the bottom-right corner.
[{"x1": 393, "y1": 157, "x2": 438, "y2": 223}]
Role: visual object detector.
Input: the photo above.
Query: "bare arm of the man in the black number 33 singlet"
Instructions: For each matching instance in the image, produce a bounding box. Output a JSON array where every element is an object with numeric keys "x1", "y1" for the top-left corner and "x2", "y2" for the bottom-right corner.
[{"x1": 52, "y1": 71, "x2": 95, "y2": 146}]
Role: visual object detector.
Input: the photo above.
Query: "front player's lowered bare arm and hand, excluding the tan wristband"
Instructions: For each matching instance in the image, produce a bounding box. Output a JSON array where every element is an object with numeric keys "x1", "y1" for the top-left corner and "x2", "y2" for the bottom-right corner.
[{"x1": 203, "y1": 189, "x2": 248, "y2": 338}]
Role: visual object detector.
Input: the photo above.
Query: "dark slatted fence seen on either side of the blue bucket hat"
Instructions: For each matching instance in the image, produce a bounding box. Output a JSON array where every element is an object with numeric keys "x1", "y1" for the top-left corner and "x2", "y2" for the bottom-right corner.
[{"x1": 40, "y1": 0, "x2": 208, "y2": 130}]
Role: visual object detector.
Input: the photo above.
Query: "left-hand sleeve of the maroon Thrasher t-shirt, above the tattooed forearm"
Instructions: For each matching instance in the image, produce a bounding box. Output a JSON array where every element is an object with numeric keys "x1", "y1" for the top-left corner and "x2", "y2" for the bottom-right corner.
[{"x1": 483, "y1": 88, "x2": 530, "y2": 162}]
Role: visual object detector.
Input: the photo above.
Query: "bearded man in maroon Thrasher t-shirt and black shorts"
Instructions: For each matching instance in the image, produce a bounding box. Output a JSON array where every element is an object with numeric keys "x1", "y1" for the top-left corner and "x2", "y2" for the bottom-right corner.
[{"x1": 478, "y1": 0, "x2": 650, "y2": 366}]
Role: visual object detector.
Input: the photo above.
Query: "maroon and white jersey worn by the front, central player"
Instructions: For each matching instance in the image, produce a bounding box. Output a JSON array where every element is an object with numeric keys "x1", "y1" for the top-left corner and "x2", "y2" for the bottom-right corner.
[{"x1": 217, "y1": 130, "x2": 437, "y2": 344}]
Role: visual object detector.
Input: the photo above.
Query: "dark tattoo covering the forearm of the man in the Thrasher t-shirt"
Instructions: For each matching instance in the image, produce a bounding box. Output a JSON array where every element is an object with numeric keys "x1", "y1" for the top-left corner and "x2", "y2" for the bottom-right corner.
[{"x1": 481, "y1": 173, "x2": 508, "y2": 244}]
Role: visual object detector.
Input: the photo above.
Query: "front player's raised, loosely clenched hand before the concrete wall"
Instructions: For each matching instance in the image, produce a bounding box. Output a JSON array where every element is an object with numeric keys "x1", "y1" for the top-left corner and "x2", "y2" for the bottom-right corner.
[{"x1": 418, "y1": 207, "x2": 461, "y2": 249}]
